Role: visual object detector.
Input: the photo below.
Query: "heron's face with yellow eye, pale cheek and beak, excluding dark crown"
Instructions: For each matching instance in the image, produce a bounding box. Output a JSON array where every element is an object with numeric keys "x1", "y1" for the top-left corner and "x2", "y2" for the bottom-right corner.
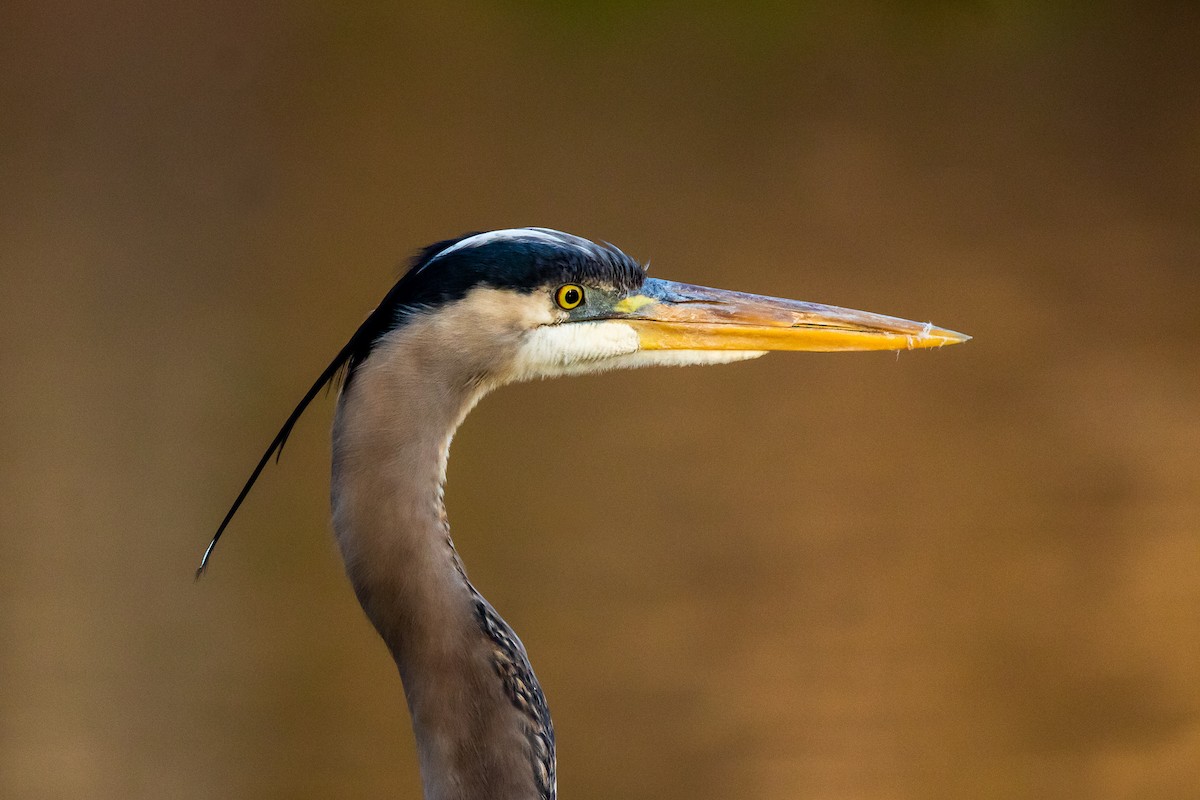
[{"x1": 436, "y1": 277, "x2": 970, "y2": 385}]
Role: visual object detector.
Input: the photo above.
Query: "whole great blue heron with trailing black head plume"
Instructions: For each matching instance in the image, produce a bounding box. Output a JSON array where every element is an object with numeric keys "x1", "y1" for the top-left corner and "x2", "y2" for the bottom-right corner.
[{"x1": 197, "y1": 228, "x2": 970, "y2": 800}]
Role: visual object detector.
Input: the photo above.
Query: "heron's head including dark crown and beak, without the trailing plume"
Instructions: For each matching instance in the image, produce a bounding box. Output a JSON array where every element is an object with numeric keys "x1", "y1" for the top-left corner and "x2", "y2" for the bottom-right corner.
[{"x1": 350, "y1": 228, "x2": 970, "y2": 386}]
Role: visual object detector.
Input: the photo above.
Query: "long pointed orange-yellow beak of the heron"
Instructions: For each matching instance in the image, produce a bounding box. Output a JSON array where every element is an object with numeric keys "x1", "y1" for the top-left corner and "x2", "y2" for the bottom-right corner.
[{"x1": 612, "y1": 278, "x2": 971, "y2": 353}]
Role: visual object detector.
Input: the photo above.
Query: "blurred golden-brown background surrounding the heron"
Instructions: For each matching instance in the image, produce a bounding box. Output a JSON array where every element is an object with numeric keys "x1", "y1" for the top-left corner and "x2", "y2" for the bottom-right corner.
[{"x1": 0, "y1": 0, "x2": 1200, "y2": 799}]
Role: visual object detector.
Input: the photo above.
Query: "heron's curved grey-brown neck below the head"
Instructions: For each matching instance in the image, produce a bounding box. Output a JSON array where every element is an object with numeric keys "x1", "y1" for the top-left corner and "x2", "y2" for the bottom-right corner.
[{"x1": 332, "y1": 328, "x2": 554, "y2": 800}]
